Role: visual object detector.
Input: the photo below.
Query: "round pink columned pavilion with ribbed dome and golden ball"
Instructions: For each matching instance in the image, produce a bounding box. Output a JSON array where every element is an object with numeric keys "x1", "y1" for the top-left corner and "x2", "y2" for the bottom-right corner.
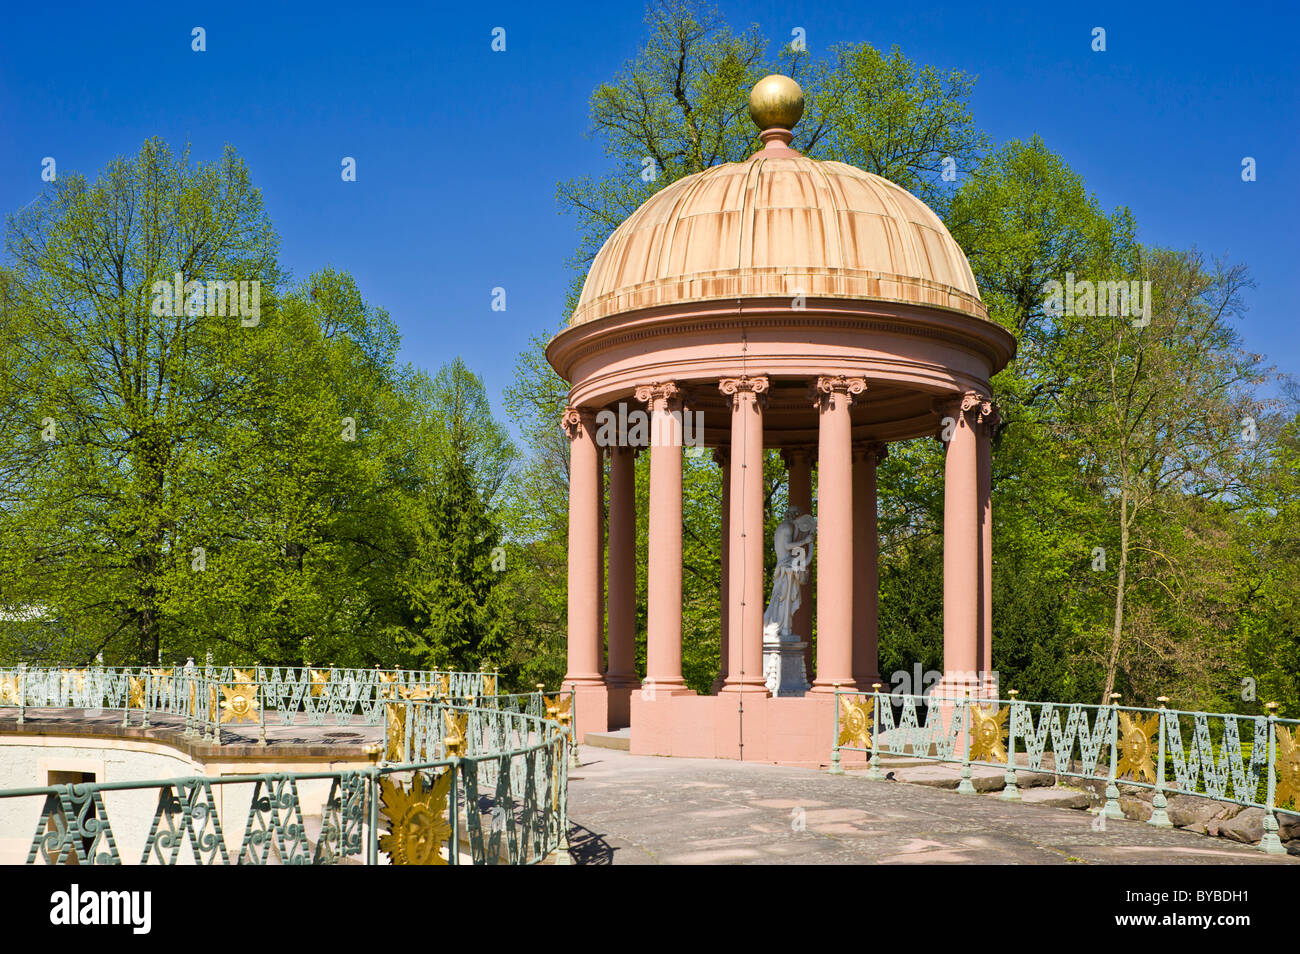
[{"x1": 546, "y1": 77, "x2": 1015, "y2": 763}]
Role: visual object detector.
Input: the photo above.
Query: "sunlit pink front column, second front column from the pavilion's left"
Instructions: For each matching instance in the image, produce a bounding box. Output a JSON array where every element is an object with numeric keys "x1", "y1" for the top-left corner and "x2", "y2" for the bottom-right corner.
[{"x1": 637, "y1": 381, "x2": 686, "y2": 693}]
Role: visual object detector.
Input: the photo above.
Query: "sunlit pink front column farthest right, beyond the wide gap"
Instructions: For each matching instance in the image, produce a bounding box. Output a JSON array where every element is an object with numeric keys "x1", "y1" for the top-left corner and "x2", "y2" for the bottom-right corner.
[{"x1": 939, "y1": 393, "x2": 982, "y2": 697}]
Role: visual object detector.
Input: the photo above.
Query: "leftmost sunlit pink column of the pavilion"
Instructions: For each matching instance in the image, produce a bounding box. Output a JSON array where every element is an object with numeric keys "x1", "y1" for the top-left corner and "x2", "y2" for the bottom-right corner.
[{"x1": 563, "y1": 407, "x2": 603, "y2": 688}]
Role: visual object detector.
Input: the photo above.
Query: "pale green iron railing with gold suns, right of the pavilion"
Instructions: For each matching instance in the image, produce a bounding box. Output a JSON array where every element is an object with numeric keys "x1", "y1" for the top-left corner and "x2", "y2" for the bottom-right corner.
[{"x1": 831, "y1": 691, "x2": 1300, "y2": 854}]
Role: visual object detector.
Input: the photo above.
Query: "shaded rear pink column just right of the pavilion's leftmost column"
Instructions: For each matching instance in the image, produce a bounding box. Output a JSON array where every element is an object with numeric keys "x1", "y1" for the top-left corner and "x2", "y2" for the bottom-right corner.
[{"x1": 605, "y1": 447, "x2": 640, "y2": 689}]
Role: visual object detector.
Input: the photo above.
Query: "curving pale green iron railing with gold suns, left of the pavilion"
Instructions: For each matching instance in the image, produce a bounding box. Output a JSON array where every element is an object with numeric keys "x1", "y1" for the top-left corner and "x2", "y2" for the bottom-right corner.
[{"x1": 0, "y1": 667, "x2": 576, "y2": 864}]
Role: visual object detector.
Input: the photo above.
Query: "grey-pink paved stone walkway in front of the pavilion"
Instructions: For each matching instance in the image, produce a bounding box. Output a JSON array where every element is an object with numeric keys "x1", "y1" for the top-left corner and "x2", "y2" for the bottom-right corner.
[{"x1": 568, "y1": 746, "x2": 1300, "y2": 864}]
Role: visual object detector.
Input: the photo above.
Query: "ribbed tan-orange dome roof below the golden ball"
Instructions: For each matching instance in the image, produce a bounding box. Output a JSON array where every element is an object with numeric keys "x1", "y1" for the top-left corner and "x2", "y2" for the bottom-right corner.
[{"x1": 571, "y1": 149, "x2": 988, "y2": 325}]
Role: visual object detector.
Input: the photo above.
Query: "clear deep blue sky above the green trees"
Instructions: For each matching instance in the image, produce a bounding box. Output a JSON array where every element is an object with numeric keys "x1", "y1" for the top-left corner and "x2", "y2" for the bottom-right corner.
[{"x1": 0, "y1": 0, "x2": 1300, "y2": 426}]
